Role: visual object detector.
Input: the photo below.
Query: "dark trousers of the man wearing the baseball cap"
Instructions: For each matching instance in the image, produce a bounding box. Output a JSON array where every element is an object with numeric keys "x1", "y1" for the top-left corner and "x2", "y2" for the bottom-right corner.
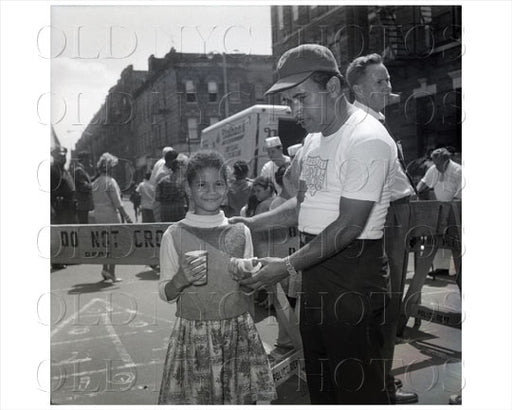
[{"x1": 300, "y1": 240, "x2": 389, "y2": 404}]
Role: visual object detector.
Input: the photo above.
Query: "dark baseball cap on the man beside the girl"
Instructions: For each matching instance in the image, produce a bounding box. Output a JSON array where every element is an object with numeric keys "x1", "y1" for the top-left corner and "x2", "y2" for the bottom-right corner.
[{"x1": 265, "y1": 44, "x2": 341, "y2": 95}]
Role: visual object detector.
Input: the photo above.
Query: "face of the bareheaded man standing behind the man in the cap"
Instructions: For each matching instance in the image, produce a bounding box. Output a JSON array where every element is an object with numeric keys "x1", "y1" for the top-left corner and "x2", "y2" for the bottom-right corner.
[{"x1": 353, "y1": 64, "x2": 391, "y2": 112}]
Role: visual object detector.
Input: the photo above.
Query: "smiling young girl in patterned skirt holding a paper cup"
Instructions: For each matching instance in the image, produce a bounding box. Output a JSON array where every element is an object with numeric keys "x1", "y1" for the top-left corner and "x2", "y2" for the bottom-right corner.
[{"x1": 158, "y1": 151, "x2": 277, "y2": 404}]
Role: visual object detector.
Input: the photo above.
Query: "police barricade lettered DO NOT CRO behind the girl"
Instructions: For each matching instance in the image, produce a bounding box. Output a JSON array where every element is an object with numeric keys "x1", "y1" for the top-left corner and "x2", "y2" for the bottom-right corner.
[{"x1": 50, "y1": 223, "x2": 304, "y2": 385}]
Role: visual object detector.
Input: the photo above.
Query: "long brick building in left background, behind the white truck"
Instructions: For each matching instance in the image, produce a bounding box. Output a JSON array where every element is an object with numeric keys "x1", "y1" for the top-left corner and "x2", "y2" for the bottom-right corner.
[{"x1": 76, "y1": 49, "x2": 273, "y2": 179}]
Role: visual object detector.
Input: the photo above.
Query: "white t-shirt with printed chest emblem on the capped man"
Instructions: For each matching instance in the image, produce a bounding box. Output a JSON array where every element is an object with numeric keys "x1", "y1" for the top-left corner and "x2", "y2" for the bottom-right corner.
[{"x1": 299, "y1": 109, "x2": 399, "y2": 239}]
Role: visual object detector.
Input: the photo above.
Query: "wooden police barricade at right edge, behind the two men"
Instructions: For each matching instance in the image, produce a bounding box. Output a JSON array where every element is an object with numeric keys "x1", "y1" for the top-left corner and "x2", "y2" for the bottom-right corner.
[{"x1": 398, "y1": 201, "x2": 462, "y2": 334}]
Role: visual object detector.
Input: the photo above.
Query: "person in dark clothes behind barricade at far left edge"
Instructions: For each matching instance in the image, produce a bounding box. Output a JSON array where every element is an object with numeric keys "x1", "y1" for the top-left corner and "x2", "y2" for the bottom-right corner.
[{"x1": 50, "y1": 146, "x2": 77, "y2": 225}]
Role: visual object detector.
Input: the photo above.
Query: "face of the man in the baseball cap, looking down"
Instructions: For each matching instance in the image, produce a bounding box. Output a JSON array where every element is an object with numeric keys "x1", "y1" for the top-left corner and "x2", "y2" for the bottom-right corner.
[{"x1": 281, "y1": 78, "x2": 334, "y2": 132}]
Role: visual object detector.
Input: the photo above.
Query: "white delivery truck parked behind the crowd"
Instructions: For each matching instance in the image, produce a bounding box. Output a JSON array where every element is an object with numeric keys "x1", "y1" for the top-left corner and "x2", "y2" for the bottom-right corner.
[{"x1": 201, "y1": 105, "x2": 307, "y2": 178}]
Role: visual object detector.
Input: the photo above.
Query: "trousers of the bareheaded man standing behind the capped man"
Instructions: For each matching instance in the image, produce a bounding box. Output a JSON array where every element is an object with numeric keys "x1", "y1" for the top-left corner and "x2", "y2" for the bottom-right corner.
[{"x1": 383, "y1": 202, "x2": 411, "y2": 401}]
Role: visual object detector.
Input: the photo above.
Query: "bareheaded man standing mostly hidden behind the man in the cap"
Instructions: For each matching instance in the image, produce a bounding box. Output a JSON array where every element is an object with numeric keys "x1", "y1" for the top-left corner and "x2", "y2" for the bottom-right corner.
[{"x1": 345, "y1": 53, "x2": 418, "y2": 404}]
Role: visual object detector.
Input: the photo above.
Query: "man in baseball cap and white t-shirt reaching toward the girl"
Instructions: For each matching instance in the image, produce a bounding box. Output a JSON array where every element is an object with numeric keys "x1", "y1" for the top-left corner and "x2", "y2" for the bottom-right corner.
[{"x1": 236, "y1": 44, "x2": 398, "y2": 404}]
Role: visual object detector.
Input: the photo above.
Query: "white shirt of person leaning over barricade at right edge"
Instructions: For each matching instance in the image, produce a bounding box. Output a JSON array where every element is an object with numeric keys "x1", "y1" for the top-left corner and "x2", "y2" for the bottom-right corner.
[{"x1": 421, "y1": 159, "x2": 462, "y2": 201}]
